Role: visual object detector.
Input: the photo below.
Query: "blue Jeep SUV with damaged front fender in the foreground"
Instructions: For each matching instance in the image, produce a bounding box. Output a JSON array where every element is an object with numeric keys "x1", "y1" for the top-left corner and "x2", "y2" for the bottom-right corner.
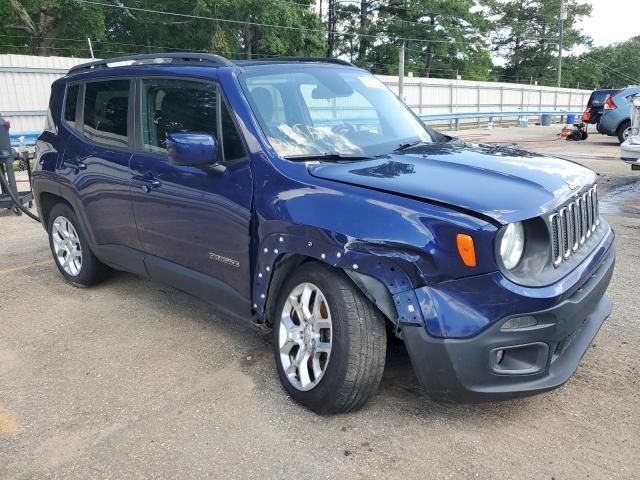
[{"x1": 33, "y1": 54, "x2": 614, "y2": 413}]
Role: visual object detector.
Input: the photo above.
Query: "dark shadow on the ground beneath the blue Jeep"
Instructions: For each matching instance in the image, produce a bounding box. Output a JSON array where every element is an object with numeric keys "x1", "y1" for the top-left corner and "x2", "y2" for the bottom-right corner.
[{"x1": 95, "y1": 272, "x2": 530, "y2": 420}]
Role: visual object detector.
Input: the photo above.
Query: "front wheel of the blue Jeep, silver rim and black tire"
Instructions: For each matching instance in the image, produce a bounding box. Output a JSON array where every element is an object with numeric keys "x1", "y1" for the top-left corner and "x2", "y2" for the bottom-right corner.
[{"x1": 273, "y1": 262, "x2": 387, "y2": 414}]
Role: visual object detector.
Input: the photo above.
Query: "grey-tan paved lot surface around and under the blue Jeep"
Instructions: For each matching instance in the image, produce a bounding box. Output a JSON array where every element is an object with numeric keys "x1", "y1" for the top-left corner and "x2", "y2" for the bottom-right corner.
[{"x1": 0, "y1": 127, "x2": 640, "y2": 480}]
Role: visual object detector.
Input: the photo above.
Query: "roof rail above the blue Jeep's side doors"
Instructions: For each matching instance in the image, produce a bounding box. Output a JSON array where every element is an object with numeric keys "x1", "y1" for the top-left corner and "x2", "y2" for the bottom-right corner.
[{"x1": 67, "y1": 52, "x2": 233, "y2": 75}]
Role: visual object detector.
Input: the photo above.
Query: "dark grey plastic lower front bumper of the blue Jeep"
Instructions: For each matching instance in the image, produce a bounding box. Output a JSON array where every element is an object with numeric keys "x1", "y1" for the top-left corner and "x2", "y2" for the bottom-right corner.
[{"x1": 403, "y1": 232, "x2": 615, "y2": 402}]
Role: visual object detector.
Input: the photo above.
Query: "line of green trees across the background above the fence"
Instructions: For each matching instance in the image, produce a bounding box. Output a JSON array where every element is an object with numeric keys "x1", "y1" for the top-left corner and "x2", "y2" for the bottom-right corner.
[{"x1": 0, "y1": 0, "x2": 640, "y2": 87}]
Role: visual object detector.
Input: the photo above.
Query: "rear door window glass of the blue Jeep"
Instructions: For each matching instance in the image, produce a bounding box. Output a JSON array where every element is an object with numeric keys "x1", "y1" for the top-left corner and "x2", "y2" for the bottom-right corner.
[{"x1": 83, "y1": 80, "x2": 129, "y2": 147}]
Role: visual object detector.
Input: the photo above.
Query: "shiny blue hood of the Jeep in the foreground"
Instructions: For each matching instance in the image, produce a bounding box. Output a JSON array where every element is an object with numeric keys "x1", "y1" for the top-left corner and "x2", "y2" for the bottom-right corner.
[{"x1": 308, "y1": 140, "x2": 596, "y2": 223}]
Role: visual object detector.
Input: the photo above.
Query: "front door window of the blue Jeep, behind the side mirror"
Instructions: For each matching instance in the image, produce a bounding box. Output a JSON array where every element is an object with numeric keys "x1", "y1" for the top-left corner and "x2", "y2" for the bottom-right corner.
[{"x1": 142, "y1": 78, "x2": 218, "y2": 152}]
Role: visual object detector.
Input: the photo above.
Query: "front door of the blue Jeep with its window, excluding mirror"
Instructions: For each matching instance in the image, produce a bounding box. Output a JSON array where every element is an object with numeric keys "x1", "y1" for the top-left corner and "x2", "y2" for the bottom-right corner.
[{"x1": 131, "y1": 78, "x2": 253, "y2": 301}]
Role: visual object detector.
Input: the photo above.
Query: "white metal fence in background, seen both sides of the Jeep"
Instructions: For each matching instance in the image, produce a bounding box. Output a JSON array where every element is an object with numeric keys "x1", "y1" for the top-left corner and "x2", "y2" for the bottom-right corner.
[{"x1": 0, "y1": 55, "x2": 591, "y2": 133}]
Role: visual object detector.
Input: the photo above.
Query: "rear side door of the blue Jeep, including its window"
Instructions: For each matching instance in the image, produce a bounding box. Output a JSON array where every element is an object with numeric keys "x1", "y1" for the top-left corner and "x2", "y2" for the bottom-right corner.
[{"x1": 59, "y1": 79, "x2": 140, "y2": 248}]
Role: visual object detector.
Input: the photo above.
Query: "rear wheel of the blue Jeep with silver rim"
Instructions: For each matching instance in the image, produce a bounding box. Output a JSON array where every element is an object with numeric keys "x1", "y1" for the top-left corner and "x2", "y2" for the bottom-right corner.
[{"x1": 47, "y1": 203, "x2": 109, "y2": 287}]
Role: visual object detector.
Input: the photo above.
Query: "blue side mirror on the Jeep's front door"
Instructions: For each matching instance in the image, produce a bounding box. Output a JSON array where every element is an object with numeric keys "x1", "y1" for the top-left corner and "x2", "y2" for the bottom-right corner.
[{"x1": 167, "y1": 132, "x2": 218, "y2": 167}]
